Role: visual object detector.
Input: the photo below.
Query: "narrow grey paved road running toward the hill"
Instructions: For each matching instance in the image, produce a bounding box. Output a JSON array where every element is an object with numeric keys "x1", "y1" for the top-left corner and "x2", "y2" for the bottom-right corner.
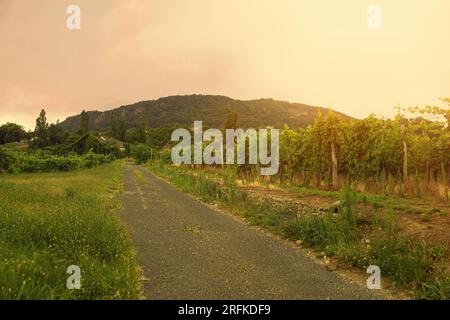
[{"x1": 120, "y1": 165, "x2": 377, "y2": 299}]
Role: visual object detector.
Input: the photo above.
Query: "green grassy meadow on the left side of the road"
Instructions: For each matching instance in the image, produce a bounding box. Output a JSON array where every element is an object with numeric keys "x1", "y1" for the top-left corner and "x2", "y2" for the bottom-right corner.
[{"x1": 0, "y1": 161, "x2": 138, "y2": 300}]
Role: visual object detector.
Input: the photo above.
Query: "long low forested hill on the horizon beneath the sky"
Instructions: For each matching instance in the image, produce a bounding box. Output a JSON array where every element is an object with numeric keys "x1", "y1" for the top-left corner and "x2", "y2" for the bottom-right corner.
[{"x1": 60, "y1": 95, "x2": 347, "y2": 131}]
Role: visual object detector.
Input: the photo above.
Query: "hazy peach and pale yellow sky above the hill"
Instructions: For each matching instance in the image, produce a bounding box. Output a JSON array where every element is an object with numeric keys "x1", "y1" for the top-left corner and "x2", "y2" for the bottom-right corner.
[{"x1": 0, "y1": 0, "x2": 450, "y2": 129}]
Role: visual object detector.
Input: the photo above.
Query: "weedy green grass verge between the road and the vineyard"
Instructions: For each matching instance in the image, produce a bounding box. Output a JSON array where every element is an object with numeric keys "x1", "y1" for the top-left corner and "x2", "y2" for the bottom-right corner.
[{"x1": 147, "y1": 162, "x2": 450, "y2": 299}]
